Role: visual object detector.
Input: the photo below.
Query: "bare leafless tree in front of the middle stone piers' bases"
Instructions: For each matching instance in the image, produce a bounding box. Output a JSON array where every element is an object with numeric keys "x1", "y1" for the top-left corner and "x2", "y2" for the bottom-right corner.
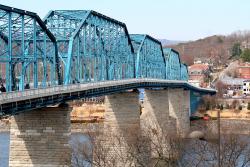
[{"x1": 72, "y1": 124, "x2": 185, "y2": 167}]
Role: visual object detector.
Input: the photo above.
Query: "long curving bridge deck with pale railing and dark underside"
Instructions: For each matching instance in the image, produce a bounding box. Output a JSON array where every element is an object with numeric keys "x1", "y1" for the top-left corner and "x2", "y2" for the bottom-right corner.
[{"x1": 0, "y1": 79, "x2": 216, "y2": 115}]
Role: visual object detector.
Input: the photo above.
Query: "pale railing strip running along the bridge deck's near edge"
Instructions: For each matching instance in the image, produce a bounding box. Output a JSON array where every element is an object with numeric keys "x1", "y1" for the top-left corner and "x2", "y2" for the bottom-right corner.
[{"x1": 0, "y1": 78, "x2": 214, "y2": 104}]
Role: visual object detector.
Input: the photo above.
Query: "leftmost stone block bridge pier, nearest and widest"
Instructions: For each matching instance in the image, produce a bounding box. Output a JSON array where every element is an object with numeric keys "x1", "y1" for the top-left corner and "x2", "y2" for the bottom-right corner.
[{"x1": 9, "y1": 104, "x2": 71, "y2": 167}]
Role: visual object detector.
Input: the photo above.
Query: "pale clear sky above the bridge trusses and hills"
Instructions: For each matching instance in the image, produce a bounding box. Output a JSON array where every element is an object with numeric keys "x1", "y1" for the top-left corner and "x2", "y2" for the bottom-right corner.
[{"x1": 0, "y1": 0, "x2": 250, "y2": 40}]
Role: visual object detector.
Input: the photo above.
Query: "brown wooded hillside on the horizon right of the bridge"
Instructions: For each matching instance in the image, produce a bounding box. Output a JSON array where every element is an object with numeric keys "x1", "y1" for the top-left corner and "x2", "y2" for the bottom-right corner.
[{"x1": 164, "y1": 31, "x2": 250, "y2": 65}]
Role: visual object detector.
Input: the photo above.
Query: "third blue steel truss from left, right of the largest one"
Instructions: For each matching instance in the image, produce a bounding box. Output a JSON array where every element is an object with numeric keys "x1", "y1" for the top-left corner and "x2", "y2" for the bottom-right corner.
[{"x1": 130, "y1": 34, "x2": 166, "y2": 79}]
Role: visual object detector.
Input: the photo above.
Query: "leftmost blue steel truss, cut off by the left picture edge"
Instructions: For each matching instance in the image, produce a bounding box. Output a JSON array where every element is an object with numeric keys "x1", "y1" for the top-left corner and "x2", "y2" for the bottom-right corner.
[{"x1": 0, "y1": 5, "x2": 61, "y2": 91}]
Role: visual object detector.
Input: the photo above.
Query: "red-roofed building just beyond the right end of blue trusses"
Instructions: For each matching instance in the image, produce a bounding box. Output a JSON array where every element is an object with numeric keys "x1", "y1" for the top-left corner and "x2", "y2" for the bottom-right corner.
[{"x1": 188, "y1": 64, "x2": 210, "y2": 87}]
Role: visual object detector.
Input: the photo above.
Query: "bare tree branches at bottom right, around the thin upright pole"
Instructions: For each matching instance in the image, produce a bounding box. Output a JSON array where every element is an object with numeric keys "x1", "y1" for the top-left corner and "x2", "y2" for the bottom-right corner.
[{"x1": 180, "y1": 124, "x2": 250, "y2": 167}]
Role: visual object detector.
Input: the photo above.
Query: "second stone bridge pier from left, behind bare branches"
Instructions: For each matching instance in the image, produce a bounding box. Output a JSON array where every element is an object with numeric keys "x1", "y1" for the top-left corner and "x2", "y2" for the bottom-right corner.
[{"x1": 100, "y1": 92, "x2": 140, "y2": 167}]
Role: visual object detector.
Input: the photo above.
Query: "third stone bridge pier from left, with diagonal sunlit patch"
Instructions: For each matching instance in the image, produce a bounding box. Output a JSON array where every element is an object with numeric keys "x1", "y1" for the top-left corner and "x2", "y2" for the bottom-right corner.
[{"x1": 141, "y1": 89, "x2": 176, "y2": 158}]
